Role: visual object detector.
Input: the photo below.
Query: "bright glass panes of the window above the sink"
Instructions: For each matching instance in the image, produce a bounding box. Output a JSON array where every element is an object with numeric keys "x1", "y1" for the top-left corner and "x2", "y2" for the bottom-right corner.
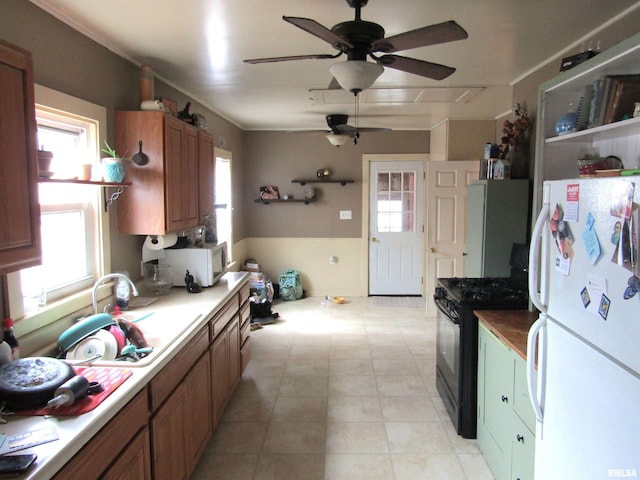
[{"x1": 20, "y1": 109, "x2": 100, "y2": 314}]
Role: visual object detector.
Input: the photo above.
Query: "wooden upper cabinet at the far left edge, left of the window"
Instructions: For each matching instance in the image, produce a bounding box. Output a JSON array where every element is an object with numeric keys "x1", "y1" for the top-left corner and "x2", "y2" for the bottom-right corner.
[{"x1": 0, "y1": 40, "x2": 42, "y2": 274}]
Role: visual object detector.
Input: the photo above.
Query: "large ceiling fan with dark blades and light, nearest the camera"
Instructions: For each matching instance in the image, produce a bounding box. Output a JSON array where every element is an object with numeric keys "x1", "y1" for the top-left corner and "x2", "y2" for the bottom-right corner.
[{"x1": 244, "y1": 0, "x2": 468, "y2": 95}]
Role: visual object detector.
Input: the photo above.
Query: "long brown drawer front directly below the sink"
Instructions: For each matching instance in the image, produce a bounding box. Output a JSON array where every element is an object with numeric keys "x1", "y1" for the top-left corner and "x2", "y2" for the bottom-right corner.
[{"x1": 149, "y1": 326, "x2": 209, "y2": 412}]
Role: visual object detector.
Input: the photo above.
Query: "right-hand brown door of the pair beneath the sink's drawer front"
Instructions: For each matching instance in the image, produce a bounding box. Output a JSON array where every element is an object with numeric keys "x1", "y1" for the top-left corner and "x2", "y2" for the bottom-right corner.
[{"x1": 184, "y1": 351, "x2": 213, "y2": 471}]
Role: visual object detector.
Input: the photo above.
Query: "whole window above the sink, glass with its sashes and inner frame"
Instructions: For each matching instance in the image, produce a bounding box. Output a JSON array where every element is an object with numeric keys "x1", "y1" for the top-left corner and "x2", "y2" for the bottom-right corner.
[{"x1": 10, "y1": 86, "x2": 109, "y2": 318}]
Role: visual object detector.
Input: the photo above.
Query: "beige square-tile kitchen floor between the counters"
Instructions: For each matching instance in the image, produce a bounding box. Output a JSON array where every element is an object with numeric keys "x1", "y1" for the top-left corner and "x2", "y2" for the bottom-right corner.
[{"x1": 191, "y1": 297, "x2": 493, "y2": 480}]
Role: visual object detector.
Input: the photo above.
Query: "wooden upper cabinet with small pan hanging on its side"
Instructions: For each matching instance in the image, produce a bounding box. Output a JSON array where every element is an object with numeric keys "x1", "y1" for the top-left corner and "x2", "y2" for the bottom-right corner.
[{"x1": 116, "y1": 111, "x2": 213, "y2": 235}]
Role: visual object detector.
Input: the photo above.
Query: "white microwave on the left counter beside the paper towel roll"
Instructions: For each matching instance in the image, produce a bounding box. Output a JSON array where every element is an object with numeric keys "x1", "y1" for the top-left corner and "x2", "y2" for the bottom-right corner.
[{"x1": 158, "y1": 242, "x2": 228, "y2": 287}]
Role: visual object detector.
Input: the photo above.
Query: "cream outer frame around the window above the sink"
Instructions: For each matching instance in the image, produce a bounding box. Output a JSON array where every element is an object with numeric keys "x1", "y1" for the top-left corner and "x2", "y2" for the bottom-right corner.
[{"x1": 7, "y1": 85, "x2": 111, "y2": 337}]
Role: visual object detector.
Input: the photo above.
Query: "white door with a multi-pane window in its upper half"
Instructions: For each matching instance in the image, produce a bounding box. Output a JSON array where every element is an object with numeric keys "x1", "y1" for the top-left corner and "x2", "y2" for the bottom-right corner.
[{"x1": 369, "y1": 161, "x2": 424, "y2": 295}]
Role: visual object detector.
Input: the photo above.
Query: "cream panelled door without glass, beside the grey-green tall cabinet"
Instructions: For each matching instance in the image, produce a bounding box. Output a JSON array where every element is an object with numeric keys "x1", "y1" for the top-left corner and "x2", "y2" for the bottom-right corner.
[{"x1": 426, "y1": 160, "x2": 480, "y2": 316}]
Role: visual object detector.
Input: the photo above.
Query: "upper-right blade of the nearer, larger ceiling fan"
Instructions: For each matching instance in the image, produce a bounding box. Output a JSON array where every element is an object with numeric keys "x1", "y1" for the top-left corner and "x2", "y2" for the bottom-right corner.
[{"x1": 373, "y1": 20, "x2": 469, "y2": 53}]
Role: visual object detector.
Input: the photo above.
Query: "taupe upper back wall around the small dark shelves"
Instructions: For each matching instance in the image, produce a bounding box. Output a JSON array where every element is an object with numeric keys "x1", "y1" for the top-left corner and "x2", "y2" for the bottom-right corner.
[{"x1": 242, "y1": 131, "x2": 429, "y2": 238}]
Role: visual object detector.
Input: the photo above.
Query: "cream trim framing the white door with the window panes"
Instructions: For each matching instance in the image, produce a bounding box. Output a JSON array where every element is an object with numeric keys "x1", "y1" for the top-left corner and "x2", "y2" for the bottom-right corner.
[{"x1": 360, "y1": 153, "x2": 430, "y2": 297}]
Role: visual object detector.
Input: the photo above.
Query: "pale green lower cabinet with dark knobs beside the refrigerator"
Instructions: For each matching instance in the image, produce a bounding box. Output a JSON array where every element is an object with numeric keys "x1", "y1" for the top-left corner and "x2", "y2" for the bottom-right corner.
[{"x1": 478, "y1": 321, "x2": 535, "y2": 480}]
